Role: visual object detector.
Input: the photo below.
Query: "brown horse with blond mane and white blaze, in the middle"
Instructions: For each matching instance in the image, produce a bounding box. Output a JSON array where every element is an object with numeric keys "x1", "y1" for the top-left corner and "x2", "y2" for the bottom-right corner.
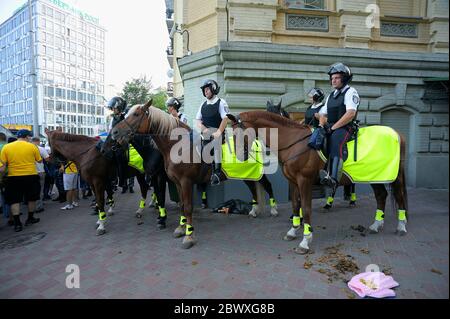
[{"x1": 111, "y1": 100, "x2": 278, "y2": 248}]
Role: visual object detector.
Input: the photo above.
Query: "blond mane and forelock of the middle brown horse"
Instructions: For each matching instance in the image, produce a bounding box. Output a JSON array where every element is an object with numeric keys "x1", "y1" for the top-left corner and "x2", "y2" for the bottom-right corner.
[{"x1": 127, "y1": 104, "x2": 191, "y2": 135}]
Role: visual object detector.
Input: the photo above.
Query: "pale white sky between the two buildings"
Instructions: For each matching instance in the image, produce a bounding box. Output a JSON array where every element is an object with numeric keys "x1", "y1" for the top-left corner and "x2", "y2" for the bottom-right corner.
[{"x1": 0, "y1": 0, "x2": 170, "y2": 97}]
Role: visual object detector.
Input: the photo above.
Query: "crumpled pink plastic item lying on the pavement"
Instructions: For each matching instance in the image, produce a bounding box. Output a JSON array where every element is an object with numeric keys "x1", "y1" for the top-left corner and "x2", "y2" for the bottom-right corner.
[{"x1": 348, "y1": 272, "x2": 398, "y2": 298}]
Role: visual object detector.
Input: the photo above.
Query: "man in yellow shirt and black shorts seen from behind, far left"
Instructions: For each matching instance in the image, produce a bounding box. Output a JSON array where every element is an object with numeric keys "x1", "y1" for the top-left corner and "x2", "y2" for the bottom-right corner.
[{"x1": 0, "y1": 130, "x2": 42, "y2": 232}]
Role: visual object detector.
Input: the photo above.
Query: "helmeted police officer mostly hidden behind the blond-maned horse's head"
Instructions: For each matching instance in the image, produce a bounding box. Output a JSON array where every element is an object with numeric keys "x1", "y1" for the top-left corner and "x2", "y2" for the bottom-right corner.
[{"x1": 107, "y1": 96, "x2": 128, "y2": 193}]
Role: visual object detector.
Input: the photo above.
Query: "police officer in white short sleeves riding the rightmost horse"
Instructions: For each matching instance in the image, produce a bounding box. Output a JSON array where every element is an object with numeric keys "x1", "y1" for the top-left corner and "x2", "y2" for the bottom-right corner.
[{"x1": 319, "y1": 62, "x2": 360, "y2": 190}]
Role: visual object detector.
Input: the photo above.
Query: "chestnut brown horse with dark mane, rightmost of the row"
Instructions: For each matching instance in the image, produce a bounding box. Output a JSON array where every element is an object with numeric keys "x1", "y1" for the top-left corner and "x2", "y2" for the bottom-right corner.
[{"x1": 228, "y1": 111, "x2": 407, "y2": 254}]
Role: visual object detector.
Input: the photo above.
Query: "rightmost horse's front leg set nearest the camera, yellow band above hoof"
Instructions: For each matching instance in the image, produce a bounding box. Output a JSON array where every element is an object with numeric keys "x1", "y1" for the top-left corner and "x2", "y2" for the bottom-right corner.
[{"x1": 295, "y1": 177, "x2": 313, "y2": 255}]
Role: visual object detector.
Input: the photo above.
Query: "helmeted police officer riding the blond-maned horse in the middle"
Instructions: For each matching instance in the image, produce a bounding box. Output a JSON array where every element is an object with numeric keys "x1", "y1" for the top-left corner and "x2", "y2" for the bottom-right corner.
[{"x1": 195, "y1": 80, "x2": 229, "y2": 185}]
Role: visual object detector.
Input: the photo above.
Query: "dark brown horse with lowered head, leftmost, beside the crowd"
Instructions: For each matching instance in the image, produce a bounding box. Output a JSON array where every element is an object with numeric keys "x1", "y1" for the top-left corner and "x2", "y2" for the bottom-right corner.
[{"x1": 45, "y1": 129, "x2": 148, "y2": 235}]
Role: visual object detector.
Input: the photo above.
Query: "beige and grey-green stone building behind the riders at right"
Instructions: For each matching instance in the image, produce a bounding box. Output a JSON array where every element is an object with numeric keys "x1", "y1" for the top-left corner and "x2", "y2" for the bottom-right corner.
[{"x1": 167, "y1": 0, "x2": 449, "y2": 195}]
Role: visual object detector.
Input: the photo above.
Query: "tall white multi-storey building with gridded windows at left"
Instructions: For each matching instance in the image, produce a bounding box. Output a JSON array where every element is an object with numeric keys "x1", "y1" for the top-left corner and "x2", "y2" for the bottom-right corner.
[{"x1": 0, "y1": 0, "x2": 106, "y2": 136}]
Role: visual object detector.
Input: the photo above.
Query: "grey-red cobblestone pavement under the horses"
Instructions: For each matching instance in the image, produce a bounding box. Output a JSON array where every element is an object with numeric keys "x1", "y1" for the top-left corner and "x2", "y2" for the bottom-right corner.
[{"x1": 0, "y1": 189, "x2": 449, "y2": 299}]
